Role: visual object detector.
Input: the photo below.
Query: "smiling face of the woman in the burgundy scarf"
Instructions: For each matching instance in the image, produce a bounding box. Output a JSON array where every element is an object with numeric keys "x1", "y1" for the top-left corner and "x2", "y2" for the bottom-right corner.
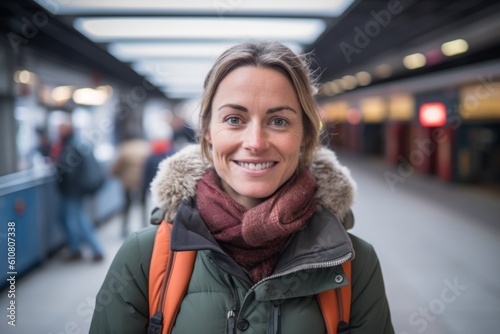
[{"x1": 206, "y1": 66, "x2": 304, "y2": 208}]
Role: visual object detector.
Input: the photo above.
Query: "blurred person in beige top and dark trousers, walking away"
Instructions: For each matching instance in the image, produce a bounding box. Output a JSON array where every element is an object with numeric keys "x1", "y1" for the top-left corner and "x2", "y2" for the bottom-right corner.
[{"x1": 111, "y1": 134, "x2": 151, "y2": 237}]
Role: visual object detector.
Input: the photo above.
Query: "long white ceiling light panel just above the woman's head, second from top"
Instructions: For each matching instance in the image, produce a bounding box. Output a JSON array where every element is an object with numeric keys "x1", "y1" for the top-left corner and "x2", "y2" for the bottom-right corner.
[{"x1": 74, "y1": 17, "x2": 326, "y2": 44}]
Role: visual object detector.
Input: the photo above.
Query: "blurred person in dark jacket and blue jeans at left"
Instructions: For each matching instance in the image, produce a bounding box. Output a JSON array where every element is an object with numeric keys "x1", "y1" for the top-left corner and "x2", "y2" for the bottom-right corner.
[{"x1": 51, "y1": 116, "x2": 104, "y2": 261}]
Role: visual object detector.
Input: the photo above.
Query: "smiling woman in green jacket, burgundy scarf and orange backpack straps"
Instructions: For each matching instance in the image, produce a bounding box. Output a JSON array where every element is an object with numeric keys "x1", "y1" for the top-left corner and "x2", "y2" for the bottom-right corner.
[{"x1": 90, "y1": 42, "x2": 394, "y2": 334}]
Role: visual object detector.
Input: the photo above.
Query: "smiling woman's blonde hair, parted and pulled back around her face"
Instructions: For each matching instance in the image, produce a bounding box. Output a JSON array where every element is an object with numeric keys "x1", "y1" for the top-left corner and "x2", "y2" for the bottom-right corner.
[{"x1": 199, "y1": 42, "x2": 321, "y2": 166}]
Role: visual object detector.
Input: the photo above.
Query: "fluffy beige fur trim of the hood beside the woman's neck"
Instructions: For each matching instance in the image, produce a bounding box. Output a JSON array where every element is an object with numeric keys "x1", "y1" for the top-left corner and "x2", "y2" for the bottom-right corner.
[{"x1": 151, "y1": 144, "x2": 356, "y2": 229}]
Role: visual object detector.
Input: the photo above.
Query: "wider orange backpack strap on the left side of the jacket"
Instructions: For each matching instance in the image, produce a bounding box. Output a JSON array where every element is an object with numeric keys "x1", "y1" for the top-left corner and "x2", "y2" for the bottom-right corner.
[{"x1": 148, "y1": 221, "x2": 196, "y2": 334}]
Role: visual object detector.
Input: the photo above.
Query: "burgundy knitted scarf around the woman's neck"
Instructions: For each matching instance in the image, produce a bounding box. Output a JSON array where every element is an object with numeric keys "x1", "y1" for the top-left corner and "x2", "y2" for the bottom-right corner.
[{"x1": 196, "y1": 168, "x2": 316, "y2": 283}]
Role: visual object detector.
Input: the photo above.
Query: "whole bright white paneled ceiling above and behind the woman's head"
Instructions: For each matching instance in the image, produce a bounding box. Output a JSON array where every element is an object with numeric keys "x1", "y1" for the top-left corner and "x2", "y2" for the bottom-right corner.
[{"x1": 35, "y1": 0, "x2": 353, "y2": 98}]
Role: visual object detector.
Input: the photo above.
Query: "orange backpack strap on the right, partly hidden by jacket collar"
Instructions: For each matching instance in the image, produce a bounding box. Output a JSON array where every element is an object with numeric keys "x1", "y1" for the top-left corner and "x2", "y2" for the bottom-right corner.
[{"x1": 318, "y1": 261, "x2": 352, "y2": 334}]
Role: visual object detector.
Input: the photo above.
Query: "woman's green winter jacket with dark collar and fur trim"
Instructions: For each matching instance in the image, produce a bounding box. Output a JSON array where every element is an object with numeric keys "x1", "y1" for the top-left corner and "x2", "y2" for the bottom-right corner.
[{"x1": 90, "y1": 148, "x2": 394, "y2": 334}]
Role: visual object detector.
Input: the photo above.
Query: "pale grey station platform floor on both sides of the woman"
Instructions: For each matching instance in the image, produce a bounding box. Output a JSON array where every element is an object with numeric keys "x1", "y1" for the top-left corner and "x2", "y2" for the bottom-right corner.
[{"x1": 0, "y1": 153, "x2": 500, "y2": 334}]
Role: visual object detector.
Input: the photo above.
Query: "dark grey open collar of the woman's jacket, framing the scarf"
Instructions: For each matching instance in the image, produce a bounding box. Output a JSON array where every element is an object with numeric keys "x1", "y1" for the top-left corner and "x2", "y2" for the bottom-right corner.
[{"x1": 170, "y1": 199, "x2": 354, "y2": 288}]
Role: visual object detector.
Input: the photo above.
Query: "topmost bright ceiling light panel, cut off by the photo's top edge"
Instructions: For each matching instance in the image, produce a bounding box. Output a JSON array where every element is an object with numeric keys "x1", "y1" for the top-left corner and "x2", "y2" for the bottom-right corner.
[{"x1": 35, "y1": 0, "x2": 353, "y2": 17}]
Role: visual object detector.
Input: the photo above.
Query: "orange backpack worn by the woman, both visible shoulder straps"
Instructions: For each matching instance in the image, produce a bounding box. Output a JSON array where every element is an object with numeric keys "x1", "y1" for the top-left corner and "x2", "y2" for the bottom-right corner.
[{"x1": 148, "y1": 221, "x2": 351, "y2": 334}]
